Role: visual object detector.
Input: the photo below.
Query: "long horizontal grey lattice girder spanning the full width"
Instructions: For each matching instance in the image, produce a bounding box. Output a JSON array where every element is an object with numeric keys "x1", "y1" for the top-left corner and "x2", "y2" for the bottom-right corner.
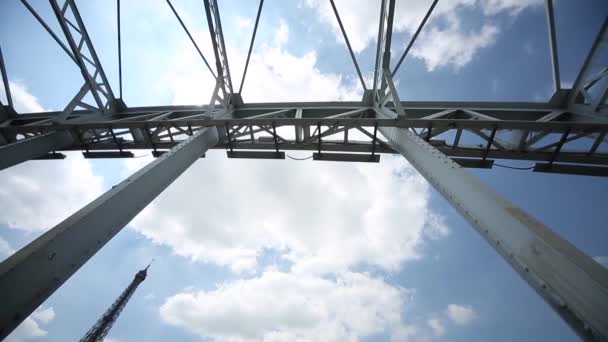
[{"x1": 0, "y1": 102, "x2": 608, "y2": 174}]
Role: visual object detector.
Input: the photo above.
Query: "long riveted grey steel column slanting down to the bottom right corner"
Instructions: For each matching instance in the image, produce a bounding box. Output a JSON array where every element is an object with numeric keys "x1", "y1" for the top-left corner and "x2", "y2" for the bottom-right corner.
[{"x1": 378, "y1": 108, "x2": 608, "y2": 341}]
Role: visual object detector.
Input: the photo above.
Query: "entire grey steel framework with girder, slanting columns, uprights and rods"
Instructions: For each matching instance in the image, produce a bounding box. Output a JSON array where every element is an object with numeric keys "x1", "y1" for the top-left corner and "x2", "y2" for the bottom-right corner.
[{"x1": 0, "y1": 0, "x2": 608, "y2": 340}]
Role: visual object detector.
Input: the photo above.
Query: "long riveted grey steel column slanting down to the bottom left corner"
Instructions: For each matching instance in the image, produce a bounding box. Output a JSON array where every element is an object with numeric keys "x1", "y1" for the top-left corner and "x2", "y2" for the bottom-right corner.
[{"x1": 0, "y1": 127, "x2": 218, "y2": 340}]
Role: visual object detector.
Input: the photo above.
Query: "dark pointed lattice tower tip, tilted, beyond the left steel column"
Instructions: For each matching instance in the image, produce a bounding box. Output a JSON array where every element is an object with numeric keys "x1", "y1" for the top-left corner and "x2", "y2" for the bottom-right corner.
[{"x1": 80, "y1": 264, "x2": 150, "y2": 342}]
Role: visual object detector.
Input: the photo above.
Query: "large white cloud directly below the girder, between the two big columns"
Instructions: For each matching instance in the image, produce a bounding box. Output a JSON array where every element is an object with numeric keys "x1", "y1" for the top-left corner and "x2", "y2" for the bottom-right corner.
[{"x1": 132, "y1": 151, "x2": 447, "y2": 273}]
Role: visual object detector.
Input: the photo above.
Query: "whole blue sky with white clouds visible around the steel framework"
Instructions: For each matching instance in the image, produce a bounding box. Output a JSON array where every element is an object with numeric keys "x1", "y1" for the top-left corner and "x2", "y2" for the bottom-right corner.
[{"x1": 0, "y1": 0, "x2": 608, "y2": 341}]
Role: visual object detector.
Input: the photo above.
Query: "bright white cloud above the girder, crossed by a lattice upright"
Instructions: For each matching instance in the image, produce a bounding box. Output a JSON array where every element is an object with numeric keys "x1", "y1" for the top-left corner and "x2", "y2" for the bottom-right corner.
[{"x1": 164, "y1": 16, "x2": 363, "y2": 104}]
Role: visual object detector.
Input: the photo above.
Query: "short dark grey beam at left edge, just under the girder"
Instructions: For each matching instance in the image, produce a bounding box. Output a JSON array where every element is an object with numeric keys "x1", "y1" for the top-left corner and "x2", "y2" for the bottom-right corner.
[{"x1": 0, "y1": 131, "x2": 74, "y2": 170}]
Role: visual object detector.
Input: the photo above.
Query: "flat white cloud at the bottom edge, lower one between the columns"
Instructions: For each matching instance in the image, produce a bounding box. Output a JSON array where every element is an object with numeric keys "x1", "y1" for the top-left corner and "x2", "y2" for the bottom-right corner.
[{"x1": 160, "y1": 272, "x2": 413, "y2": 341}]
